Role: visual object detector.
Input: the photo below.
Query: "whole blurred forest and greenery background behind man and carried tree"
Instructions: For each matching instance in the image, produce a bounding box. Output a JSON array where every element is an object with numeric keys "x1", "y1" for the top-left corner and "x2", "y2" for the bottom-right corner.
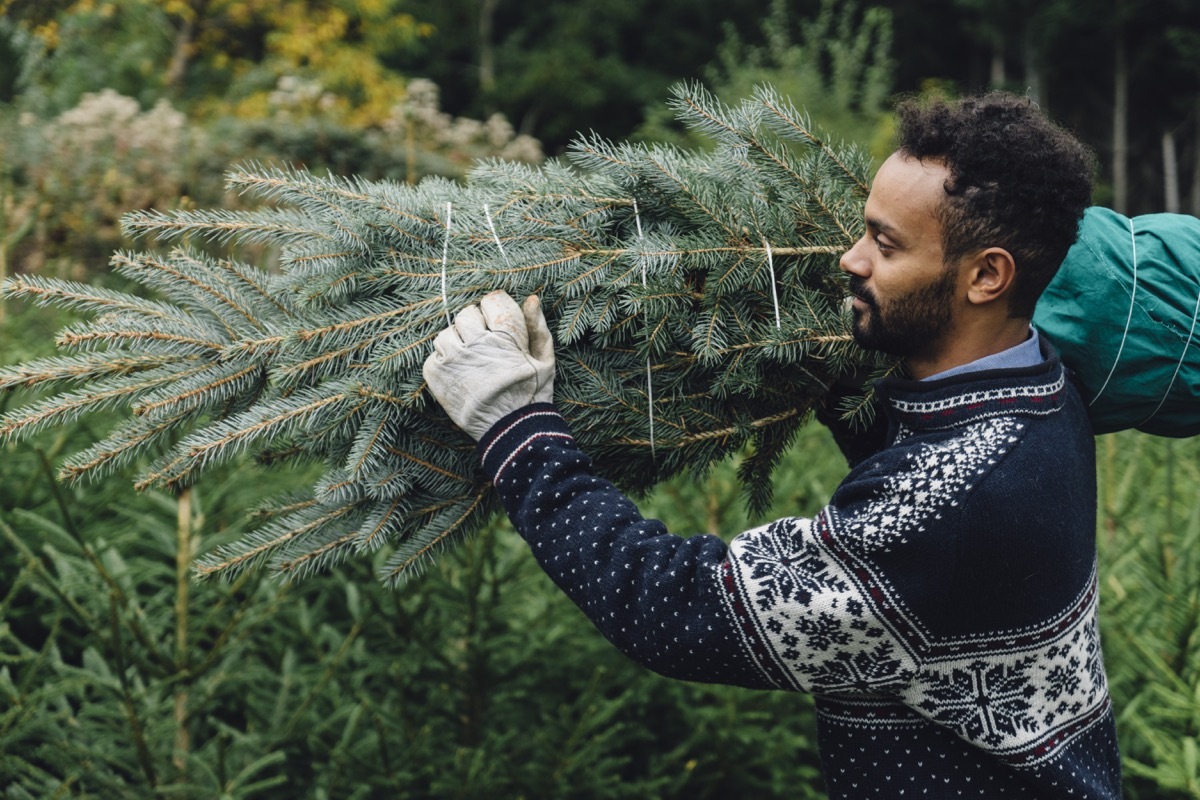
[{"x1": 0, "y1": 0, "x2": 1200, "y2": 800}]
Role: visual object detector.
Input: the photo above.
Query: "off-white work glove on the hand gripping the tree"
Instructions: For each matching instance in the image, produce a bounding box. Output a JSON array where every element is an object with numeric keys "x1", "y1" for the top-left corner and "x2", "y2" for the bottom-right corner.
[{"x1": 422, "y1": 290, "x2": 554, "y2": 441}]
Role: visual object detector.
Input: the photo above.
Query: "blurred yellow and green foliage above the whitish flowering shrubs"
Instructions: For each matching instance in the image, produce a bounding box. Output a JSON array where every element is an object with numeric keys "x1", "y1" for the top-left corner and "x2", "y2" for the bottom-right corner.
[{"x1": 0, "y1": 0, "x2": 428, "y2": 126}]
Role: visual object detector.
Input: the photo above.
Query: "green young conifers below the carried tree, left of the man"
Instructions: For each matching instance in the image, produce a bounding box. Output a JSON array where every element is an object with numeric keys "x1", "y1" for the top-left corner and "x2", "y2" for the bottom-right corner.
[{"x1": 0, "y1": 303, "x2": 840, "y2": 800}]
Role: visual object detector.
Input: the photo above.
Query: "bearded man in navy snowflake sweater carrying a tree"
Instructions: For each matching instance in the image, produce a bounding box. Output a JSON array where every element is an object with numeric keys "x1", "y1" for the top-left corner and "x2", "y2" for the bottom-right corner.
[{"x1": 425, "y1": 94, "x2": 1120, "y2": 799}]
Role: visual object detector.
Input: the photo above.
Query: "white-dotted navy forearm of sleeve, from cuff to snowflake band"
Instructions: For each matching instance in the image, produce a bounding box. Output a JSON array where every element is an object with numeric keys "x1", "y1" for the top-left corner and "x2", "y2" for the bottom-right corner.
[{"x1": 478, "y1": 404, "x2": 787, "y2": 688}]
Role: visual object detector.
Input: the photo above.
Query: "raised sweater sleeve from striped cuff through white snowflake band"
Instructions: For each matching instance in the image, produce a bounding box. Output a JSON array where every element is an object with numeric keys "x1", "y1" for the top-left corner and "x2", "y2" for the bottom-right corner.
[{"x1": 479, "y1": 404, "x2": 912, "y2": 693}]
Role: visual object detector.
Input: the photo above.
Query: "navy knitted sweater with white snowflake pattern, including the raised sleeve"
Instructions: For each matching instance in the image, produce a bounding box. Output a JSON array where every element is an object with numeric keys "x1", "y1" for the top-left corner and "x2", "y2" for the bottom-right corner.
[{"x1": 479, "y1": 356, "x2": 1121, "y2": 800}]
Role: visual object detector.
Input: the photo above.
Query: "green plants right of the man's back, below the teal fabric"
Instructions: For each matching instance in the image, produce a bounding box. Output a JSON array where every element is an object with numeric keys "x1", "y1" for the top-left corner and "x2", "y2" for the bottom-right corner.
[{"x1": 1098, "y1": 432, "x2": 1200, "y2": 800}]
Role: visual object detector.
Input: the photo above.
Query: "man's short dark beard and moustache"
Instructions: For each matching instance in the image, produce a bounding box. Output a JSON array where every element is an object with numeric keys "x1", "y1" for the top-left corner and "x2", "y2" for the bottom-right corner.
[{"x1": 850, "y1": 269, "x2": 958, "y2": 357}]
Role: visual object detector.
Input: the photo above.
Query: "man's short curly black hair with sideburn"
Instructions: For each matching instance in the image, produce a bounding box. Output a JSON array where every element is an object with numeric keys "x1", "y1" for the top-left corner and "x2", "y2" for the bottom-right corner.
[{"x1": 896, "y1": 91, "x2": 1096, "y2": 318}]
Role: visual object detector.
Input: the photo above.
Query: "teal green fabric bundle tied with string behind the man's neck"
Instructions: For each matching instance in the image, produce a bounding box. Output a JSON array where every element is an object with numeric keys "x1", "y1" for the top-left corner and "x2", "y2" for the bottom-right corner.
[{"x1": 1033, "y1": 207, "x2": 1200, "y2": 437}]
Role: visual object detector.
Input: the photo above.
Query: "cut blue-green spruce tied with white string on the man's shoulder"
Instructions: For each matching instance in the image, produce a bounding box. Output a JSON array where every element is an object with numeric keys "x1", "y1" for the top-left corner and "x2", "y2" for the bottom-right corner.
[{"x1": 0, "y1": 88, "x2": 882, "y2": 584}]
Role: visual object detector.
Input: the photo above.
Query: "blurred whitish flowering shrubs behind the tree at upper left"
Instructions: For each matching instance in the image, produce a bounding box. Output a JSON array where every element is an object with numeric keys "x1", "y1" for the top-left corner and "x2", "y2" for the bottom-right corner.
[{"x1": 0, "y1": 76, "x2": 542, "y2": 278}]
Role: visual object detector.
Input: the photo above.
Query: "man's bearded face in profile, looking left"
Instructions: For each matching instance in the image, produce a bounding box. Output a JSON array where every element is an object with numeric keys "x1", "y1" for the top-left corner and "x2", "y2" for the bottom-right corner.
[{"x1": 841, "y1": 154, "x2": 959, "y2": 357}]
